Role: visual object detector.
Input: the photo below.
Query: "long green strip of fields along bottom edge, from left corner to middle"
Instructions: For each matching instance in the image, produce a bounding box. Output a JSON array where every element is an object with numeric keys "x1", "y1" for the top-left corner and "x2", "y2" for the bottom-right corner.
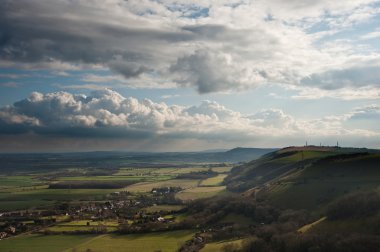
[{"x1": 0, "y1": 230, "x2": 194, "y2": 252}]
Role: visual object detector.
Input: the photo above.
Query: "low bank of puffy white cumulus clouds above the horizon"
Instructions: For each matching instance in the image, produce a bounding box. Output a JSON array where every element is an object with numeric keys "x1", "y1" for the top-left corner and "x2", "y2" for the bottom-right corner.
[{"x1": 0, "y1": 89, "x2": 380, "y2": 150}]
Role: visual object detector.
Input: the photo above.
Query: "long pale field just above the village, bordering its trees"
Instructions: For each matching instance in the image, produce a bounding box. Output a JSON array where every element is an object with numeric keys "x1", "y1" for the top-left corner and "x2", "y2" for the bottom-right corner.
[{"x1": 126, "y1": 179, "x2": 199, "y2": 192}]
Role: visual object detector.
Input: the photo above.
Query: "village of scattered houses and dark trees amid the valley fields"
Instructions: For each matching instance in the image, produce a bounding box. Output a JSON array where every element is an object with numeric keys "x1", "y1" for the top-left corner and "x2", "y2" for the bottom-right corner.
[{"x1": 0, "y1": 187, "x2": 187, "y2": 239}]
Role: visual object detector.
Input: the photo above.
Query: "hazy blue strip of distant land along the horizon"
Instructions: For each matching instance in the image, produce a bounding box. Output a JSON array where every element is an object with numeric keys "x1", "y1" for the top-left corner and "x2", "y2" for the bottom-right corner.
[{"x1": 0, "y1": 148, "x2": 277, "y2": 172}]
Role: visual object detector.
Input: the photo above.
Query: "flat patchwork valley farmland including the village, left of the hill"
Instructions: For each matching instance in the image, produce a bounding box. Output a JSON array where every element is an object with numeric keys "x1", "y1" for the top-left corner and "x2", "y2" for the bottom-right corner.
[{"x1": 0, "y1": 151, "x2": 249, "y2": 252}]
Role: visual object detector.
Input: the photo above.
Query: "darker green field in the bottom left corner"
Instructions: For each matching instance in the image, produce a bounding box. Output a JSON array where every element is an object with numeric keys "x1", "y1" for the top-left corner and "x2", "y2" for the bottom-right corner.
[{"x1": 0, "y1": 234, "x2": 95, "y2": 252}]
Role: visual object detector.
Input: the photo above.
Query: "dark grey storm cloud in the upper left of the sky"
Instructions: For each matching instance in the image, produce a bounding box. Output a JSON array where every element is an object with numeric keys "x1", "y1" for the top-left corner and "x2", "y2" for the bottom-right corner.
[{"x1": 0, "y1": 0, "x2": 191, "y2": 67}]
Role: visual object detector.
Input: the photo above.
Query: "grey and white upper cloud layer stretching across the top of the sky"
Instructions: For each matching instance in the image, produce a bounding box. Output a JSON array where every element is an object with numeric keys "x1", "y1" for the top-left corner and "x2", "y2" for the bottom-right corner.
[{"x1": 0, "y1": 0, "x2": 380, "y2": 93}]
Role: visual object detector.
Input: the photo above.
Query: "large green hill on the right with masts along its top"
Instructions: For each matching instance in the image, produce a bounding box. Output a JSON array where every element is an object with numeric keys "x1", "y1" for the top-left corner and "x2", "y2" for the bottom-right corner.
[{"x1": 225, "y1": 146, "x2": 380, "y2": 209}]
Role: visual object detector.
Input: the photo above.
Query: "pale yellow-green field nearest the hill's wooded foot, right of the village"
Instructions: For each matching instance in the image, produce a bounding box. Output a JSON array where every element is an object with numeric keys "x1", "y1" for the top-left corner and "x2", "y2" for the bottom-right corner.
[{"x1": 176, "y1": 186, "x2": 226, "y2": 201}]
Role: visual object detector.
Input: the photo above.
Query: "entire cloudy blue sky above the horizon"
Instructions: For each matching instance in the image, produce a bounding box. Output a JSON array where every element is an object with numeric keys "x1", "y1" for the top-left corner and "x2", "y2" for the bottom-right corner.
[{"x1": 0, "y1": 0, "x2": 380, "y2": 152}]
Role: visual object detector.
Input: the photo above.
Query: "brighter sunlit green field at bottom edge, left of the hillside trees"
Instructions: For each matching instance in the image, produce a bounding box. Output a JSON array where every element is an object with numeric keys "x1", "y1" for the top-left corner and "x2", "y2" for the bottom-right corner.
[{"x1": 67, "y1": 230, "x2": 194, "y2": 252}]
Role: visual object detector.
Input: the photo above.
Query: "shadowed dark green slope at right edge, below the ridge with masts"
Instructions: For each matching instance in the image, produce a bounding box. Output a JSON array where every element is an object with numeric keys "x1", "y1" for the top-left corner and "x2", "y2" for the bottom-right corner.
[{"x1": 269, "y1": 154, "x2": 380, "y2": 209}]
